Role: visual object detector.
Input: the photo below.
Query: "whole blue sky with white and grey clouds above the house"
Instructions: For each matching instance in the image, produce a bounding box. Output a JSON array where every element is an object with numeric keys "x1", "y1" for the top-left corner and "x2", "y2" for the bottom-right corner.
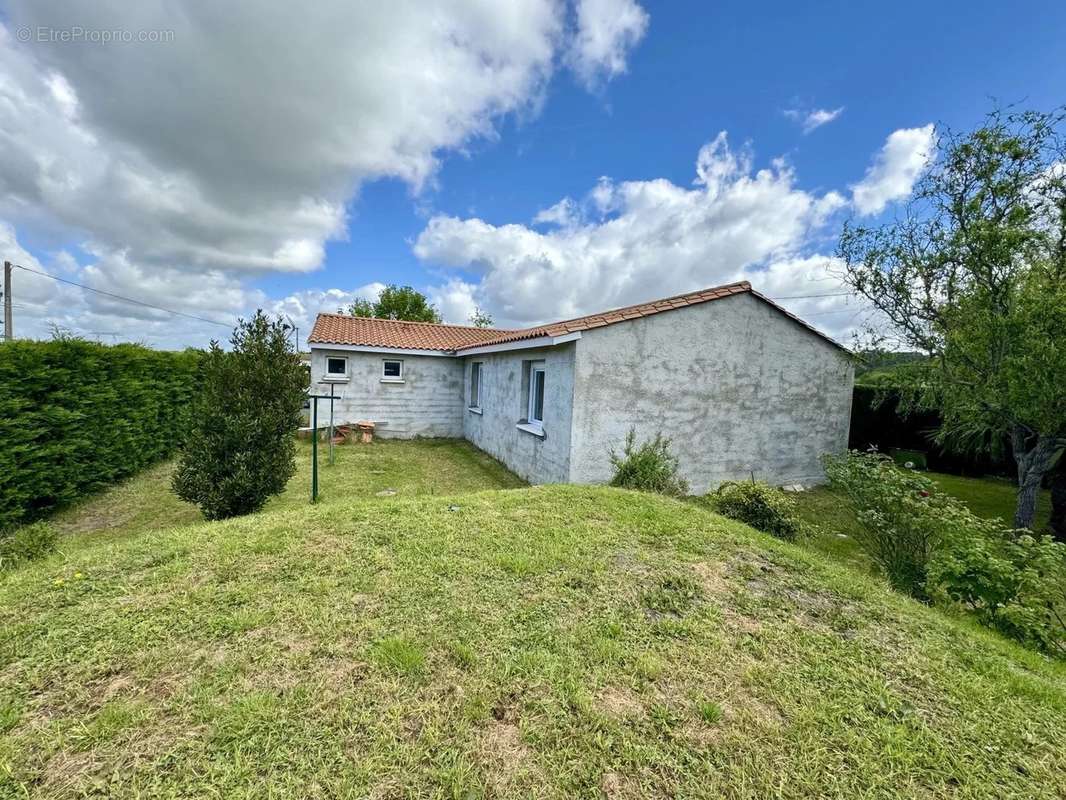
[{"x1": 0, "y1": 0, "x2": 1066, "y2": 348}]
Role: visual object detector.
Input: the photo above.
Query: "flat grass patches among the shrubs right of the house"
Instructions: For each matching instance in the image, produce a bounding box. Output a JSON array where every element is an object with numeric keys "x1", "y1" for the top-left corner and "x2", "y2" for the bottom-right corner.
[{"x1": 791, "y1": 473, "x2": 1051, "y2": 572}]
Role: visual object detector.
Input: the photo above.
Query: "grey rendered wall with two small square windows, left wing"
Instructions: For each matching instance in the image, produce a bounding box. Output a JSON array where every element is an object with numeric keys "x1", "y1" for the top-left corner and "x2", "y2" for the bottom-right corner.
[{"x1": 311, "y1": 347, "x2": 464, "y2": 438}]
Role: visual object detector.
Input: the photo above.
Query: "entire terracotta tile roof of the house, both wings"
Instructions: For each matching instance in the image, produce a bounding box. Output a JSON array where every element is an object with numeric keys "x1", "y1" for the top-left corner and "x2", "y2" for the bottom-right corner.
[{"x1": 307, "y1": 281, "x2": 844, "y2": 352}]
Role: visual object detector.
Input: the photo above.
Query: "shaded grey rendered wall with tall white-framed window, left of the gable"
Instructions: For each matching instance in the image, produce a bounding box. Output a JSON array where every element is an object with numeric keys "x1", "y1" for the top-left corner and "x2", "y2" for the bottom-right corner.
[{"x1": 461, "y1": 343, "x2": 575, "y2": 483}]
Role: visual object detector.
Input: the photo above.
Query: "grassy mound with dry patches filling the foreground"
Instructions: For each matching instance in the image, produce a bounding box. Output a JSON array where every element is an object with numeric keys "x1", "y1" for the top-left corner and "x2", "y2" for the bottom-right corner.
[{"x1": 0, "y1": 486, "x2": 1066, "y2": 798}]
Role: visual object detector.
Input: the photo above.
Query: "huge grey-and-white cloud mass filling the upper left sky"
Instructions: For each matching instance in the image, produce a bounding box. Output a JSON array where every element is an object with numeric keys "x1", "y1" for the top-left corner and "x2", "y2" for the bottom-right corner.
[{"x1": 0, "y1": 0, "x2": 647, "y2": 341}]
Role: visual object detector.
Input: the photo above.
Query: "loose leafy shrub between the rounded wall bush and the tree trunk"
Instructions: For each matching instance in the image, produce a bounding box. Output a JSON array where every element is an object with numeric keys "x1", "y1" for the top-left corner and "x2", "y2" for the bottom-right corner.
[{"x1": 824, "y1": 450, "x2": 969, "y2": 601}]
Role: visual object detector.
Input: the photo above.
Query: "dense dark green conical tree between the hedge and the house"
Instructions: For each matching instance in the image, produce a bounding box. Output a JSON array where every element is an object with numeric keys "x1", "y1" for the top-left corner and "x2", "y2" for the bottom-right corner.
[{"x1": 173, "y1": 310, "x2": 307, "y2": 519}]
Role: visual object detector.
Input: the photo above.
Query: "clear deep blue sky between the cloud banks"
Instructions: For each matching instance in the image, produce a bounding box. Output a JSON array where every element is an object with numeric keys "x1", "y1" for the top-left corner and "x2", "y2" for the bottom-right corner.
[{"x1": 262, "y1": 2, "x2": 1066, "y2": 309}]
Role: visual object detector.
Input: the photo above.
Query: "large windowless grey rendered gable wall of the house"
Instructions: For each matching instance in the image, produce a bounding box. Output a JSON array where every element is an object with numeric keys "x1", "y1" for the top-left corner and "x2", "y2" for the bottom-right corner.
[{"x1": 570, "y1": 294, "x2": 853, "y2": 493}]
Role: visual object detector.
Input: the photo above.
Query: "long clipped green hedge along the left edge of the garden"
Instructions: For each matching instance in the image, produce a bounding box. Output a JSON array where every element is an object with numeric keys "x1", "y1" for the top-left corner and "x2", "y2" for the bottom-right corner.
[{"x1": 0, "y1": 340, "x2": 200, "y2": 531}]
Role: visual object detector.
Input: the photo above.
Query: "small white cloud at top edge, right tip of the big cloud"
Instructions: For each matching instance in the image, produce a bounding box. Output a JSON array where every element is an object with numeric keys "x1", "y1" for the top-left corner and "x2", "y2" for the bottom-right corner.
[{"x1": 569, "y1": 0, "x2": 649, "y2": 89}]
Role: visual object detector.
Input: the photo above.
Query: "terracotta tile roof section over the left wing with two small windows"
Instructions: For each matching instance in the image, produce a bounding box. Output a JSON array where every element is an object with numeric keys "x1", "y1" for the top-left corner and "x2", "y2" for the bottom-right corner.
[{"x1": 307, "y1": 314, "x2": 506, "y2": 352}]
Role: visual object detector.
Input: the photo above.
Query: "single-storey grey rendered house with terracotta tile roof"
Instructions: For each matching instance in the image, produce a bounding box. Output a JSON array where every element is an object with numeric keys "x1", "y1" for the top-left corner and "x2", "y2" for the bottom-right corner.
[{"x1": 308, "y1": 282, "x2": 853, "y2": 492}]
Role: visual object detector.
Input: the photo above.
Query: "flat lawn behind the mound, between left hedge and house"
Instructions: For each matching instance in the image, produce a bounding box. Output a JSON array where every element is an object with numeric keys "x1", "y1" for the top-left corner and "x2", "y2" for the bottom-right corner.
[{"x1": 51, "y1": 438, "x2": 526, "y2": 535}]
